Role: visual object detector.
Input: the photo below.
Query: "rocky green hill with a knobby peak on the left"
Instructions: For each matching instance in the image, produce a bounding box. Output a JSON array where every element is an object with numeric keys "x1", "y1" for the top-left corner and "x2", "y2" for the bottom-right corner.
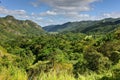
[{"x1": 0, "y1": 15, "x2": 45, "y2": 39}]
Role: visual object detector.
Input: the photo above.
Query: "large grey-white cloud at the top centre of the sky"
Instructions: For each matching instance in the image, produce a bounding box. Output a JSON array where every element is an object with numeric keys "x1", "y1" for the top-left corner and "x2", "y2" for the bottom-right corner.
[{"x1": 32, "y1": 0, "x2": 99, "y2": 12}]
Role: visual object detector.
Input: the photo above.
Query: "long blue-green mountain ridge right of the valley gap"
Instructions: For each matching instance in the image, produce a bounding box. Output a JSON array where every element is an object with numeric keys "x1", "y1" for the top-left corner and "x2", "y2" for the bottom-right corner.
[{"x1": 43, "y1": 18, "x2": 120, "y2": 33}]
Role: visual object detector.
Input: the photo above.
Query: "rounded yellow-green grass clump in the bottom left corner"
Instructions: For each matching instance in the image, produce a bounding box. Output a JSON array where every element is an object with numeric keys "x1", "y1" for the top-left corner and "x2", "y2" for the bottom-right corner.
[{"x1": 0, "y1": 66, "x2": 27, "y2": 80}]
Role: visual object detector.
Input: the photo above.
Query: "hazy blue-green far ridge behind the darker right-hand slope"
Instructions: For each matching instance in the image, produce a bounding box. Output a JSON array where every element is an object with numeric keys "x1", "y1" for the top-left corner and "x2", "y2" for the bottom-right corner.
[{"x1": 43, "y1": 21, "x2": 97, "y2": 32}]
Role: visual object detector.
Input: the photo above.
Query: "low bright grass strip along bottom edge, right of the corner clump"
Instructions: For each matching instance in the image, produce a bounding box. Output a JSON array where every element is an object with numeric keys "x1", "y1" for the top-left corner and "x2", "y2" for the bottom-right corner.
[{"x1": 28, "y1": 71, "x2": 112, "y2": 80}]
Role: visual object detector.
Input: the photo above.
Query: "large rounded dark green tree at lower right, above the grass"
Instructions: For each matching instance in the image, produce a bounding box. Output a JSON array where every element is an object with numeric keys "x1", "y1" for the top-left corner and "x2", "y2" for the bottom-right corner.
[{"x1": 85, "y1": 52, "x2": 111, "y2": 73}]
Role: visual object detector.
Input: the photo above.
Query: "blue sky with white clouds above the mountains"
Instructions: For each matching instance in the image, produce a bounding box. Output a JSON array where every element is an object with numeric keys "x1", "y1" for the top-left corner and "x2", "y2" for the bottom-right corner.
[{"x1": 0, "y1": 0, "x2": 120, "y2": 27}]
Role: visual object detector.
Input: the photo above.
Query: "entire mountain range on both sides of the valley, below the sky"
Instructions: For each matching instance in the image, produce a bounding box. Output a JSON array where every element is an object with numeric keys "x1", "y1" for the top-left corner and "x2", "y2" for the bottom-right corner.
[{"x1": 0, "y1": 15, "x2": 120, "y2": 40}]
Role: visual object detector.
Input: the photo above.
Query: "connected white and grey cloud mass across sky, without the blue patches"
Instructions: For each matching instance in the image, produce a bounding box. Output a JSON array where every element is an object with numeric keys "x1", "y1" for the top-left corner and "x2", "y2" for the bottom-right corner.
[{"x1": 0, "y1": 0, "x2": 120, "y2": 26}]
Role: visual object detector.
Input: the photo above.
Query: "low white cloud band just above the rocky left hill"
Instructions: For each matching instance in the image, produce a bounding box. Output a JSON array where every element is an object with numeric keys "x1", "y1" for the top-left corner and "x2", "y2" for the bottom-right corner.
[{"x1": 0, "y1": 6, "x2": 43, "y2": 24}]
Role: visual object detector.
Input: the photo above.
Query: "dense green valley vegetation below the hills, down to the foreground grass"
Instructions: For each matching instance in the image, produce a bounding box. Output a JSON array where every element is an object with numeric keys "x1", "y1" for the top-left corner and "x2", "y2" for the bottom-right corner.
[{"x1": 0, "y1": 17, "x2": 120, "y2": 80}]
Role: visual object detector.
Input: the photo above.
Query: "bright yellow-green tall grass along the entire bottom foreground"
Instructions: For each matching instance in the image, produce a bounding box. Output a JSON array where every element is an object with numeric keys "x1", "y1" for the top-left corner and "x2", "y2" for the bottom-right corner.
[{"x1": 0, "y1": 66, "x2": 112, "y2": 80}]
